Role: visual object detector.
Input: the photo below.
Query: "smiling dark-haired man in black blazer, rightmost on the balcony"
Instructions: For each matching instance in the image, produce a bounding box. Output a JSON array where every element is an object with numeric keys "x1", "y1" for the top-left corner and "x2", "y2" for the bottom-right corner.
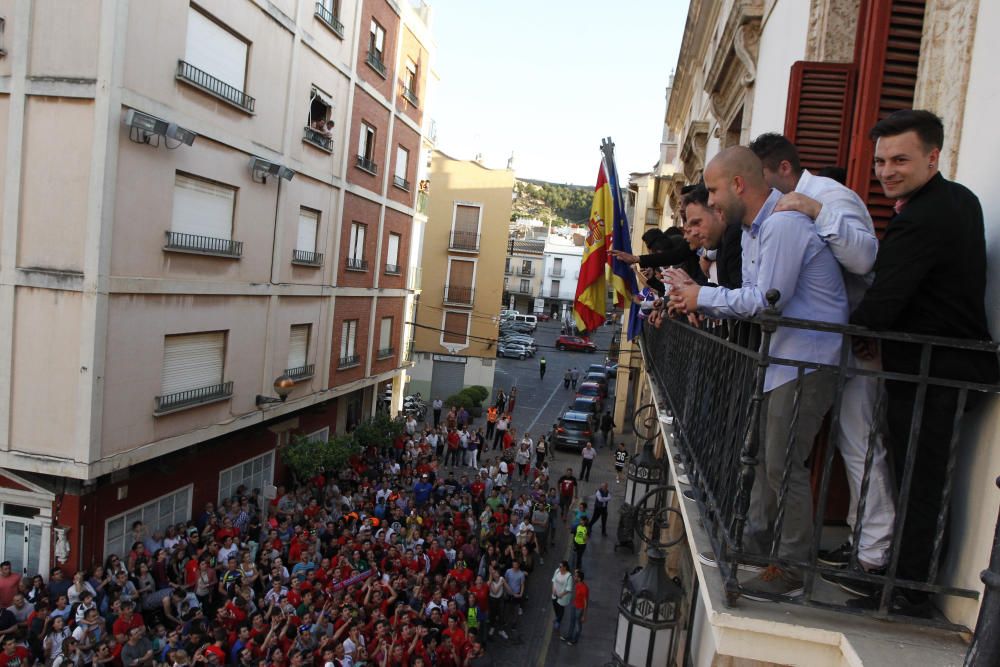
[{"x1": 851, "y1": 110, "x2": 998, "y2": 615}]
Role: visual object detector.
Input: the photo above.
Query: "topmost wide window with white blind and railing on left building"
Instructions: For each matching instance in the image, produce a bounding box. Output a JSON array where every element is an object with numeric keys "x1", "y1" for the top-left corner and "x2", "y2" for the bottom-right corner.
[{"x1": 183, "y1": 7, "x2": 254, "y2": 112}]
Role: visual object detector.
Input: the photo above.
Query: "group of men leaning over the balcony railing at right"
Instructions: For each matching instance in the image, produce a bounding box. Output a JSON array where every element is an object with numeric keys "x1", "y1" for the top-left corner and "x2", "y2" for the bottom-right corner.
[{"x1": 612, "y1": 110, "x2": 998, "y2": 616}]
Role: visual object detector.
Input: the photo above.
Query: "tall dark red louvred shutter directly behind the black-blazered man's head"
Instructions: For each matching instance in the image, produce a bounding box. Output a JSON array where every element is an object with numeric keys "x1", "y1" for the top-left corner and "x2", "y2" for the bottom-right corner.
[{"x1": 847, "y1": 0, "x2": 927, "y2": 235}]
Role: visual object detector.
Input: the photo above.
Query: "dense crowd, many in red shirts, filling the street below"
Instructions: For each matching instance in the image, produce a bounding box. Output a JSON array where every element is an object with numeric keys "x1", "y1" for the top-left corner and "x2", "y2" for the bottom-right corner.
[{"x1": 0, "y1": 391, "x2": 610, "y2": 667}]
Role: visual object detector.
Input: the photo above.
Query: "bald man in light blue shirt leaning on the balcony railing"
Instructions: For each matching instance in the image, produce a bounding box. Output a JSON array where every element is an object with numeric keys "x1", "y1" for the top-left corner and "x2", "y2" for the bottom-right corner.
[{"x1": 667, "y1": 146, "x2": 848, "y2": 600}]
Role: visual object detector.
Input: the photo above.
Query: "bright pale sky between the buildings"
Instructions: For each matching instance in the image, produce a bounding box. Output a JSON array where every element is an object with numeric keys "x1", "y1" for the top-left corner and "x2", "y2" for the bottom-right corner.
[{"x1": 428, "y1": 0, "x2": 688, "y2": 187}]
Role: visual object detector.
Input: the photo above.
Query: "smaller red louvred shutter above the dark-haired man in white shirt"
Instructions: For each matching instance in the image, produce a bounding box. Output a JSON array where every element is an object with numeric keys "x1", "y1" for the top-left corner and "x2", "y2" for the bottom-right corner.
[{"x1": 785, "y1": 61, "x2": 855, "y2": 171}]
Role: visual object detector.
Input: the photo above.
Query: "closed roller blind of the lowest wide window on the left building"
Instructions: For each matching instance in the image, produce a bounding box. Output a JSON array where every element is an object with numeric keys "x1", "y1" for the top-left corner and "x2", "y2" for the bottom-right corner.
[{"x1": 161, "y1": 331, "x2": 226, "y2": 396}]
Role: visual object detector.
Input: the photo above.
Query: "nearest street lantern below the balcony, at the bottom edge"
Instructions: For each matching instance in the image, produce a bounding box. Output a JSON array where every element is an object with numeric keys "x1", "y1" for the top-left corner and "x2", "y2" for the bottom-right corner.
[{"x1": 613, "y1": 547, "x2": 684, "y2": 667}]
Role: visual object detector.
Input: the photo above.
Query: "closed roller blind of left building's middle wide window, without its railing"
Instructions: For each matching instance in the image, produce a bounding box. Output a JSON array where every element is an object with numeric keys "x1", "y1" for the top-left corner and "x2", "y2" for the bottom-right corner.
[{"x1": 170, "y1": 174, "x2": 236, "y2": 239}]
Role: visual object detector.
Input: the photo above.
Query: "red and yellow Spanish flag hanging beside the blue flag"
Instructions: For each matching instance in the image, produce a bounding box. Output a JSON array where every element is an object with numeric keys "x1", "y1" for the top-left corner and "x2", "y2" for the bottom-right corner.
[{"x1": 573, "y1": 160, "x2": 615, "y2": 331}]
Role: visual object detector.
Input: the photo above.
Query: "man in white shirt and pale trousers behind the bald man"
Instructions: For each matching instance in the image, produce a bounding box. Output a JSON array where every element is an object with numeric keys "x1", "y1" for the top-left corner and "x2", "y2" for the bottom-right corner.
[{"x1": 750, "y1": 133, "x2": 896, "y2": 595}]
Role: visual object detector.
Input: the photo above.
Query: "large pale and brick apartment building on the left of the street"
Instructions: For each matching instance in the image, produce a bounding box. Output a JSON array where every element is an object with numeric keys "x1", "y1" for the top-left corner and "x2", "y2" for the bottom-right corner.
[{"x1": 0, "y1": 0, "x2": 434, "y2": 575}]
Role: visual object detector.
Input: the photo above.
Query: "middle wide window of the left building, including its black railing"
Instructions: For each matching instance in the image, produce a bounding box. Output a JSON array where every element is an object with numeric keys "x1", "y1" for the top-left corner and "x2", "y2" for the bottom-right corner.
[{"x1": 167, "y1": 172, "x2": 243, "y2": 257}]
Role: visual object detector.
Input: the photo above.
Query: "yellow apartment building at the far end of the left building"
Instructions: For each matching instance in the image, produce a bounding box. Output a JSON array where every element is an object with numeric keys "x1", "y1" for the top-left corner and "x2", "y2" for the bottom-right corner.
[{"x1": 407, "y1": 150, "x2": 514, "y2": 400}]
